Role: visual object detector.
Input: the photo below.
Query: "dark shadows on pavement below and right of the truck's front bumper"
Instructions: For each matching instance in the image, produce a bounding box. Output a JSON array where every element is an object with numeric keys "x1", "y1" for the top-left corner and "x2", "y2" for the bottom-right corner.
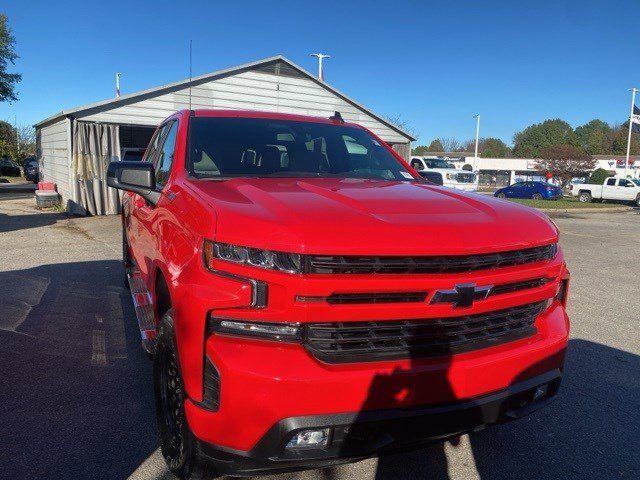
[{"x1": 360, "y1": 339, "x2": 640, "y2": 480}]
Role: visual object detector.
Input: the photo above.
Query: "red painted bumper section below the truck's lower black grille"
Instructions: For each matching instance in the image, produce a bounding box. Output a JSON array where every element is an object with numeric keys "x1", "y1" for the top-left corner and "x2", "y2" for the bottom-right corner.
[{"x1": 185, "y1": 302, "x2": 569, "y2": 452}]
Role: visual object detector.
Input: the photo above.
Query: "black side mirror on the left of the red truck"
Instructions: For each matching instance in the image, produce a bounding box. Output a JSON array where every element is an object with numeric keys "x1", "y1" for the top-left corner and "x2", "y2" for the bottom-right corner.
[{"x1": 107, "y1": 161, "x2": 160, "y2": 205}]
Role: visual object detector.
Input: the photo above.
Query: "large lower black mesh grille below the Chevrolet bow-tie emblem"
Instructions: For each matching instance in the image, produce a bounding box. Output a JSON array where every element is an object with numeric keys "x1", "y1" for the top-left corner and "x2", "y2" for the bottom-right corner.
[{"x1": 304, "y1": 302, "x2": 545, "y2": 363}]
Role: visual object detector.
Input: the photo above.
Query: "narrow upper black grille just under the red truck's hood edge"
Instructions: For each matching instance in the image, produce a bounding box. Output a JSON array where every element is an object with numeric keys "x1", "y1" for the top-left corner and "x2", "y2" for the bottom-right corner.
[{"x1": 305, "y1": 243, "x2": 558, "y2": 274}]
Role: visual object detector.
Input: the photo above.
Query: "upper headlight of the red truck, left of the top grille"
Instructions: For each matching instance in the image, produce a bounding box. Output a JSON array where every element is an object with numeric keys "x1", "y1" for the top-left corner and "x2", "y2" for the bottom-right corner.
[{"x1": 204, "y1": 240, "x2": 302, "y2": 273}]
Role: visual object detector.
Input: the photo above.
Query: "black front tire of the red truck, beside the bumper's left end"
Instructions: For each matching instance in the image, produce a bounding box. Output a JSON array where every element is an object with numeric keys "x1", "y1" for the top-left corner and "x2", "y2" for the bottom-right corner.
[{"x1": 153, "y1": 309, "x2": 215, "y2": 480}]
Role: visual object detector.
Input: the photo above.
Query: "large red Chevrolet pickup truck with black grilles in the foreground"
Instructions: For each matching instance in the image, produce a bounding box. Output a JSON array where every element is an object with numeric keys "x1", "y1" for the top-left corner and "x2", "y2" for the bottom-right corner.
[{"x1": 108, "y1": 110, "x2": 569, "y2": 478}]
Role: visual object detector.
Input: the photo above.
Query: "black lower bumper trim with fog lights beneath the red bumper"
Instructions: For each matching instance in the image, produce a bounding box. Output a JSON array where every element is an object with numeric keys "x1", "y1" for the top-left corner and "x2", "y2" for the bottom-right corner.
[{"x1": 201, "y1": 368, "x2": 564, "y2": 475}]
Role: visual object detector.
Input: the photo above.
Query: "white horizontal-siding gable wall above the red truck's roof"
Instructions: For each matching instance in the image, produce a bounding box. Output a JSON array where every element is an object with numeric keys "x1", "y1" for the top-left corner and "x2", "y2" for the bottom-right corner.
[{"x1": 79, "y1": 71, "x2": 408, "y2": 143}]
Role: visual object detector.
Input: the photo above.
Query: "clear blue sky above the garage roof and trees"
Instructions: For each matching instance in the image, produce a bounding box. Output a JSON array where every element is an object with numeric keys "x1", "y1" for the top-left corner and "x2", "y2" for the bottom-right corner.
[{"x1": 0, "y1": 0, "x2": 640, "y2": 144}]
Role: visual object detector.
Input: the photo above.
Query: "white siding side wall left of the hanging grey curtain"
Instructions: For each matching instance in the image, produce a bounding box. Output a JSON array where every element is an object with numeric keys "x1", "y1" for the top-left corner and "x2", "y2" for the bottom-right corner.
[{"x1": 39, "y1": 118, "x2": 72, "y2": 205}]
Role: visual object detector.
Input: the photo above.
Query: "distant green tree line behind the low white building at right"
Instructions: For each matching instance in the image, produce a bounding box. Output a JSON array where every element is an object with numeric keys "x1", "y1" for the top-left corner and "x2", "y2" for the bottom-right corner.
[{"x1": 412, "y1": 118, "x2": 640, "y2": 159}]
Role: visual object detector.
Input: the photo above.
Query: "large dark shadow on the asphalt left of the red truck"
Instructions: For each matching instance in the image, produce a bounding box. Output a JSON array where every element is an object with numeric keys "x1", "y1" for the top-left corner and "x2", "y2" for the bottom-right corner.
[{"x1": 0, "y1": 260, "x2": 156, "y2": 479}]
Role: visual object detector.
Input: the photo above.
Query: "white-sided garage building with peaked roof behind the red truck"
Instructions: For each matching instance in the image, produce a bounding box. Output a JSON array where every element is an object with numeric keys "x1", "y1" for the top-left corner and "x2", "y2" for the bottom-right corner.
[{"x1": 35, "y1": 56, "x2": 414, "y2": 215}]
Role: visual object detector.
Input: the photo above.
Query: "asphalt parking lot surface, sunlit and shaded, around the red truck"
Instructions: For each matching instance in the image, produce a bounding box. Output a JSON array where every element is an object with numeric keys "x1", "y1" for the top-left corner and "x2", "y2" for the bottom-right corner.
[{"x1": 0, "y1": 197, "x2": 640, "y2": 480}]
